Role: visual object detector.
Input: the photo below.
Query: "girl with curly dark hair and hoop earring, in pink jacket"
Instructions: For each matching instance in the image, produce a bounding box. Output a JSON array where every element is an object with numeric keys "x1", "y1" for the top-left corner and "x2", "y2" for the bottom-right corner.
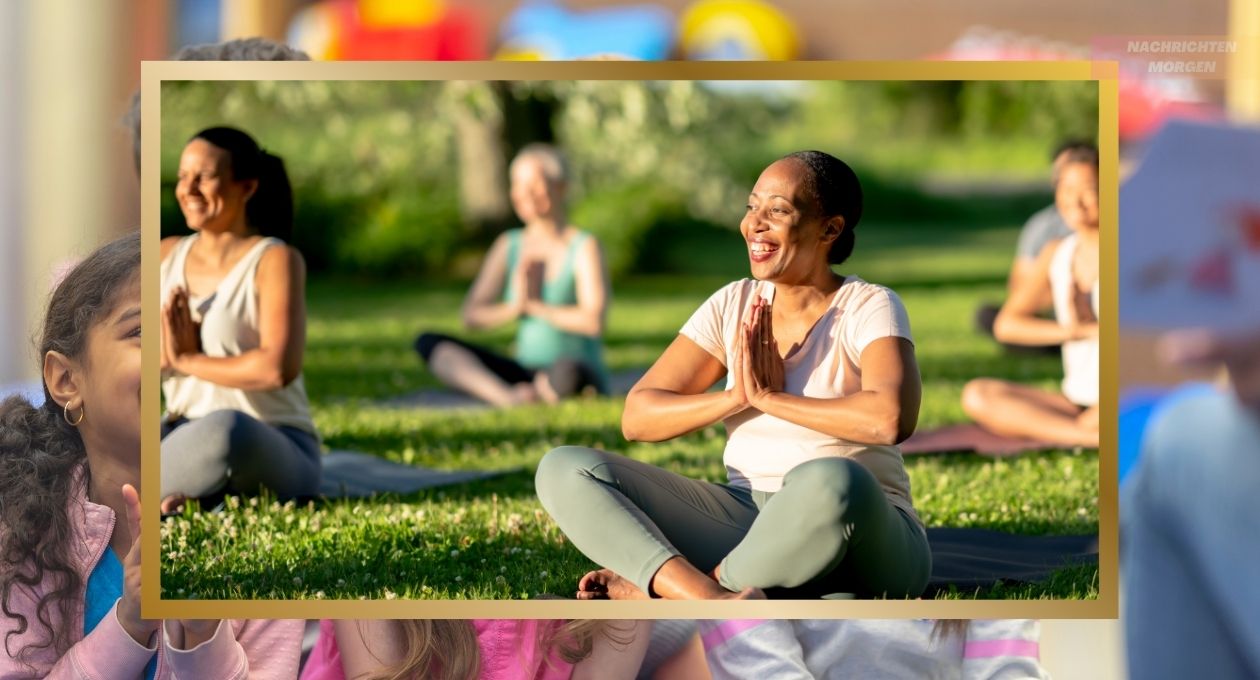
[{"x1": 0, "y1": 233, "x2": 302, "y2": 680}]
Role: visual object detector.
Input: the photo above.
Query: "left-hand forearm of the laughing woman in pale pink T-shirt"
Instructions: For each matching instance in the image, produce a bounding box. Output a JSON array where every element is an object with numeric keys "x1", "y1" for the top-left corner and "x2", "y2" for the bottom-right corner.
[{"x1": 621, "y1": 389, "x2": 747, "y2": 442}]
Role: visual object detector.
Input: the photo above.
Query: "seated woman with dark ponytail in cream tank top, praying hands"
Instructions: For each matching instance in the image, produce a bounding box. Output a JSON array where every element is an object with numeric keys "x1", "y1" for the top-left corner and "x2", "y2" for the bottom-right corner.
[{"x1": 161, "y1": 127, "x2": 320, "y2": 511}]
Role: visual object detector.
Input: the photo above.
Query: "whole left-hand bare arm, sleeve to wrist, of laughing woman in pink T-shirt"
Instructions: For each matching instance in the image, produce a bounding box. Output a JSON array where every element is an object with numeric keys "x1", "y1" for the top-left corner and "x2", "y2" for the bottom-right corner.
[{"x1": 621, "y1": 335, "x2": 747, "y2": 442}]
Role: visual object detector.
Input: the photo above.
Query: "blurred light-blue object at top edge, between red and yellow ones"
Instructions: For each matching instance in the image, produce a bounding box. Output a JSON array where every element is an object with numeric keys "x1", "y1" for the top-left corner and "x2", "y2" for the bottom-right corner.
[{"x1": 495, "y1": 1, "x2": 674, "y2": 60}]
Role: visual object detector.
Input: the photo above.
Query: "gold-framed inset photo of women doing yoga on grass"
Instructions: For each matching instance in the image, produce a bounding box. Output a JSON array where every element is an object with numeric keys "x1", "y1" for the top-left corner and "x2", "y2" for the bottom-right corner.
[{"x1": 140, "y1": 62, "x2": 1118, "y2": 618}]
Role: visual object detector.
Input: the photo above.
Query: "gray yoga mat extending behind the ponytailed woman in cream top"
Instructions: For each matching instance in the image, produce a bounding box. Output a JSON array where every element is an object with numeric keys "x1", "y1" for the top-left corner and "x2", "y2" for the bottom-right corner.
[{"x1": 320, "y1": 451, "x2": 513, "y2": 499}]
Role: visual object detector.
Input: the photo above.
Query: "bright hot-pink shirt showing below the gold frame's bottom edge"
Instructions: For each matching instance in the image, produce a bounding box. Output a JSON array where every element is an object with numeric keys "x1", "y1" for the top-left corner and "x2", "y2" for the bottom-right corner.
[{"x1": 301, "y1": 618, "x2": 573, "y2": 680}]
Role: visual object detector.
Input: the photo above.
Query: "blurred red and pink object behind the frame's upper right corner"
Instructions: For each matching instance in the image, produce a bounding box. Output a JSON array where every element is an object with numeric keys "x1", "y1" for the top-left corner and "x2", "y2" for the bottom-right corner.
[{"x1": 929, "y1": 26, "x2": 1223, "y2": 141}]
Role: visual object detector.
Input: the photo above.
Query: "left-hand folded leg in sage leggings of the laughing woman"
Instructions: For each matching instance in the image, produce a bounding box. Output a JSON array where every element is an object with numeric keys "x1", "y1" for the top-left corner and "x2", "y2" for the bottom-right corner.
[{"x1": 536, "y1": 446, "x2": 757, "y2": 593}]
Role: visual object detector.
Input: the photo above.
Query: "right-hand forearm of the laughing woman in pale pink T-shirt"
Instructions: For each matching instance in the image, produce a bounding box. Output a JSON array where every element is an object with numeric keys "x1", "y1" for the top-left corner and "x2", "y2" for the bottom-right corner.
[{"x1": 757, "y1": 392, "x2": 919, "y2": 446}]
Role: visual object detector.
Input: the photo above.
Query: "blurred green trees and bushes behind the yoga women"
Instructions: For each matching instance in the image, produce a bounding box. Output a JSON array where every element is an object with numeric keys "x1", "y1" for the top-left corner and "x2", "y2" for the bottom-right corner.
[{"x1": 161, "y1": 81, "x2": 1097, "y2": 278}]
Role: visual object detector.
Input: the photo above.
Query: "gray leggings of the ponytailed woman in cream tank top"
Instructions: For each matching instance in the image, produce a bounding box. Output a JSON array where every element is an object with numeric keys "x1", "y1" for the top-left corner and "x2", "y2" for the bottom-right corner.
[{"x1": 161, "y1": 411, "x2": 320, "y2": 499}]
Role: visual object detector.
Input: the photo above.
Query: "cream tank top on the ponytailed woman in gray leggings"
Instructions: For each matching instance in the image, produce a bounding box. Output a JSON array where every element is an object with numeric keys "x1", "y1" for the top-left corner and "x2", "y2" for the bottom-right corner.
[{"x1": 161, "y1": 234, "x2": 318, "y2": 436}]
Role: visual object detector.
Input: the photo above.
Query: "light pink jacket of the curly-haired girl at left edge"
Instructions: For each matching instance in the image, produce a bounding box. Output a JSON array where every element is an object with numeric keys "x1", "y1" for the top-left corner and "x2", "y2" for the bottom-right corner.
[{"x1": 0, "y1": 483, "x2": 304, "y2": 680}]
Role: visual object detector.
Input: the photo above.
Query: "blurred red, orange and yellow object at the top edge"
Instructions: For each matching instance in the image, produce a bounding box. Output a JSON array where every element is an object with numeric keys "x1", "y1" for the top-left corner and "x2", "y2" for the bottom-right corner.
[{"x1": 287, "y1": 0, "x2": 486, "y2": 60}]
